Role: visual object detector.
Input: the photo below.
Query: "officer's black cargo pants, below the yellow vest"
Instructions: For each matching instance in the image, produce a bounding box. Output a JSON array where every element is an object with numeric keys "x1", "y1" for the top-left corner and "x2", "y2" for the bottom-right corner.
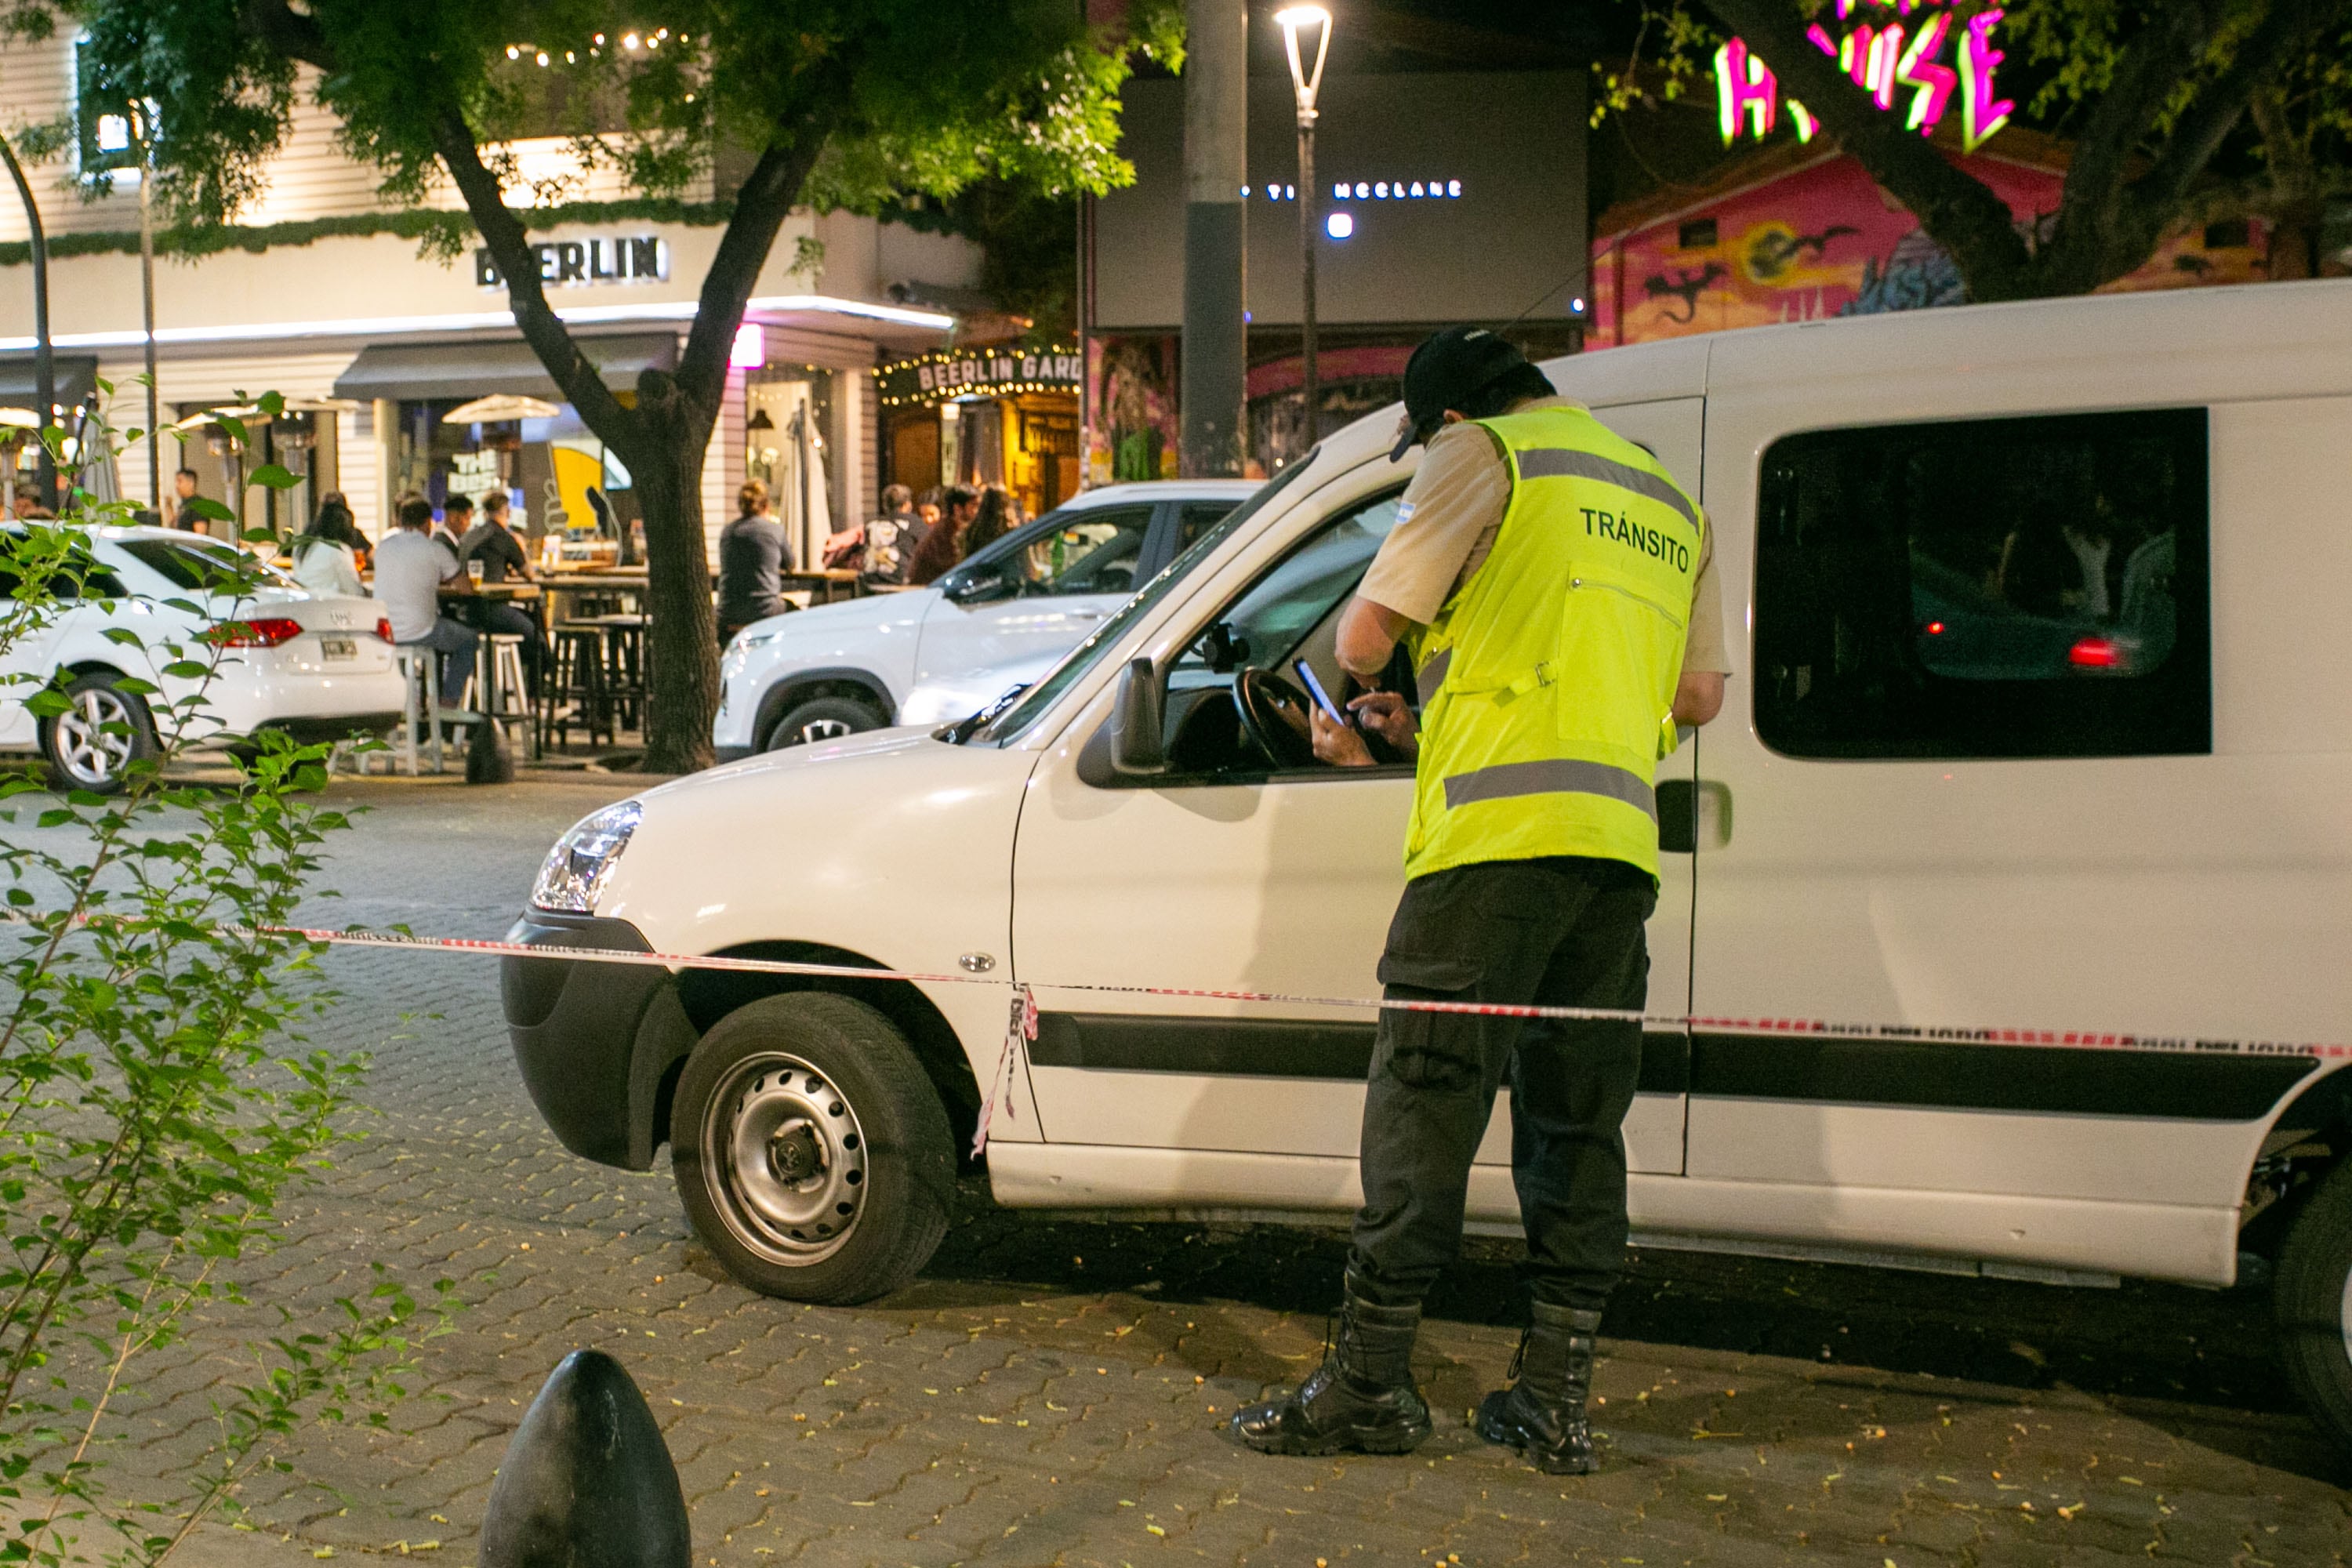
[{"x1": 1348, "y1": 855, "x2": 1658, "y2": 1312}]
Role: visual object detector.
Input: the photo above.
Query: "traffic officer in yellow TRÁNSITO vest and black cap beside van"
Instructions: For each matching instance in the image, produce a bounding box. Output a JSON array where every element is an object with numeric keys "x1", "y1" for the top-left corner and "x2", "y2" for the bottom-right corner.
[{"x1": 1232, "y1": 327, "x2": 1726, "y2": 1474}]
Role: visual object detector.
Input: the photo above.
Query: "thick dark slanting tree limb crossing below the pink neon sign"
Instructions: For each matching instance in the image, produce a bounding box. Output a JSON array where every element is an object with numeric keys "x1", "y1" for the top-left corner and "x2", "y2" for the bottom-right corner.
[{"x1": 1705, "y1": 0, "x2": 2032, "y2": 299}]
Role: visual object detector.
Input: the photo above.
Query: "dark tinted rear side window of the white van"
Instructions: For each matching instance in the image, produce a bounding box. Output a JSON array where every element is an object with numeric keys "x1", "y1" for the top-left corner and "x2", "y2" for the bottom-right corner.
[{"x1": 1755, "y1": 409, "x2": 2213, "y2": 760}]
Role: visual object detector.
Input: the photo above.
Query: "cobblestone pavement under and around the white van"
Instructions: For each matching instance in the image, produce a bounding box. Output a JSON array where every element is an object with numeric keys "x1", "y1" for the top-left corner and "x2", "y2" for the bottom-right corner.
[{"x1": 55, "y1": 779, "x2": 2352, "y2": 1568}]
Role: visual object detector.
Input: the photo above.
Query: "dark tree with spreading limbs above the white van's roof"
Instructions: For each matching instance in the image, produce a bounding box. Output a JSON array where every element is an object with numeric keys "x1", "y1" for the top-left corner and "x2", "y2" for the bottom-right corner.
[{"x1": 1602, "y1": 0, "x2": 2352, "y2": 301}]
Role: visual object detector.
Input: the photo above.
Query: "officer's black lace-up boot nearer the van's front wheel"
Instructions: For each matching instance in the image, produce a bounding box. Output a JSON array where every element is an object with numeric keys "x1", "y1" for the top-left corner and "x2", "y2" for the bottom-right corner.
[{"x1": 1232, "y1": 1274, "x2": 1430, "y2": 1453}]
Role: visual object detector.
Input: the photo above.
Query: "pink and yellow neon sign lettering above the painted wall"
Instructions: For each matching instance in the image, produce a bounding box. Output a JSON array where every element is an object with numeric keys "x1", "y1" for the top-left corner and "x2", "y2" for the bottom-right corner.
[{"x1": 1715, "y1": 0, "x2": 2016, "y2": 153}]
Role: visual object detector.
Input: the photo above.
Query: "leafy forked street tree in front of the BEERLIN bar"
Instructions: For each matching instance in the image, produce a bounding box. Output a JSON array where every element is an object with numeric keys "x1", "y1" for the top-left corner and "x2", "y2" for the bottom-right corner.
[{"x1": 12, "y1": 0, "x2": 1181, "y2": 771}]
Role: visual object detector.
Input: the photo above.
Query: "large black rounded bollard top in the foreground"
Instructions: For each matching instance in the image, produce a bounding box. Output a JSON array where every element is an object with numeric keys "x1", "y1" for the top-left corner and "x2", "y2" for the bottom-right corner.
[{"x1": 482, "y1": 1349, "x2": 694, "y2": 1568}]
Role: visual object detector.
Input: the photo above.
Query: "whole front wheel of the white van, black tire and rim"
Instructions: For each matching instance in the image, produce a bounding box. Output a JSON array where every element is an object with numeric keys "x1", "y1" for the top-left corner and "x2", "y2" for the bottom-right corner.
[{"x1": 670, "y1": 992, "x2": 955, "y2": 1305}]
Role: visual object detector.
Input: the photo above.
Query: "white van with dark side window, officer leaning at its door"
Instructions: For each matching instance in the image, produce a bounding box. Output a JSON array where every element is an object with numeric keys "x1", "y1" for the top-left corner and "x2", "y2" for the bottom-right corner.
[{"x1": 506, "y1": 282, "x2": 2352, "y2": 1439}]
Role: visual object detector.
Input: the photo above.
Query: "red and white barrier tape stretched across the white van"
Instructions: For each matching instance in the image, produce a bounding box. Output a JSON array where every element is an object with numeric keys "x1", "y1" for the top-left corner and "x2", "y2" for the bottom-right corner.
[{"x1": 27, "y1": 914, "x2": 2352, "y2": 1154}]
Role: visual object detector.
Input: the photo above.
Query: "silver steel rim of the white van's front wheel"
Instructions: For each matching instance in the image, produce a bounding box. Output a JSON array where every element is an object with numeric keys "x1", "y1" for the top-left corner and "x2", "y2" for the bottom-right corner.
[{"x1": 701, "y1": 1051, "x2": 868, "y2": 1267}]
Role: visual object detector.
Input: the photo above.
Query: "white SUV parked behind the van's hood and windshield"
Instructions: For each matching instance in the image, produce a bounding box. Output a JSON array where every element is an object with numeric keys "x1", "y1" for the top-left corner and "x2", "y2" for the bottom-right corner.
[{"x1": 710, "y1": 480, "x2": 1256, "y2": 762}]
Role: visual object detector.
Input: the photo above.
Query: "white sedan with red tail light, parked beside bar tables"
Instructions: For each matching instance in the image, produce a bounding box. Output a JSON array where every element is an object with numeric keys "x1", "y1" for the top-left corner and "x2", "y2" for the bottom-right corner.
[{"x1": 0, "y1": 529, "x2": 402, "y2": 792}]
